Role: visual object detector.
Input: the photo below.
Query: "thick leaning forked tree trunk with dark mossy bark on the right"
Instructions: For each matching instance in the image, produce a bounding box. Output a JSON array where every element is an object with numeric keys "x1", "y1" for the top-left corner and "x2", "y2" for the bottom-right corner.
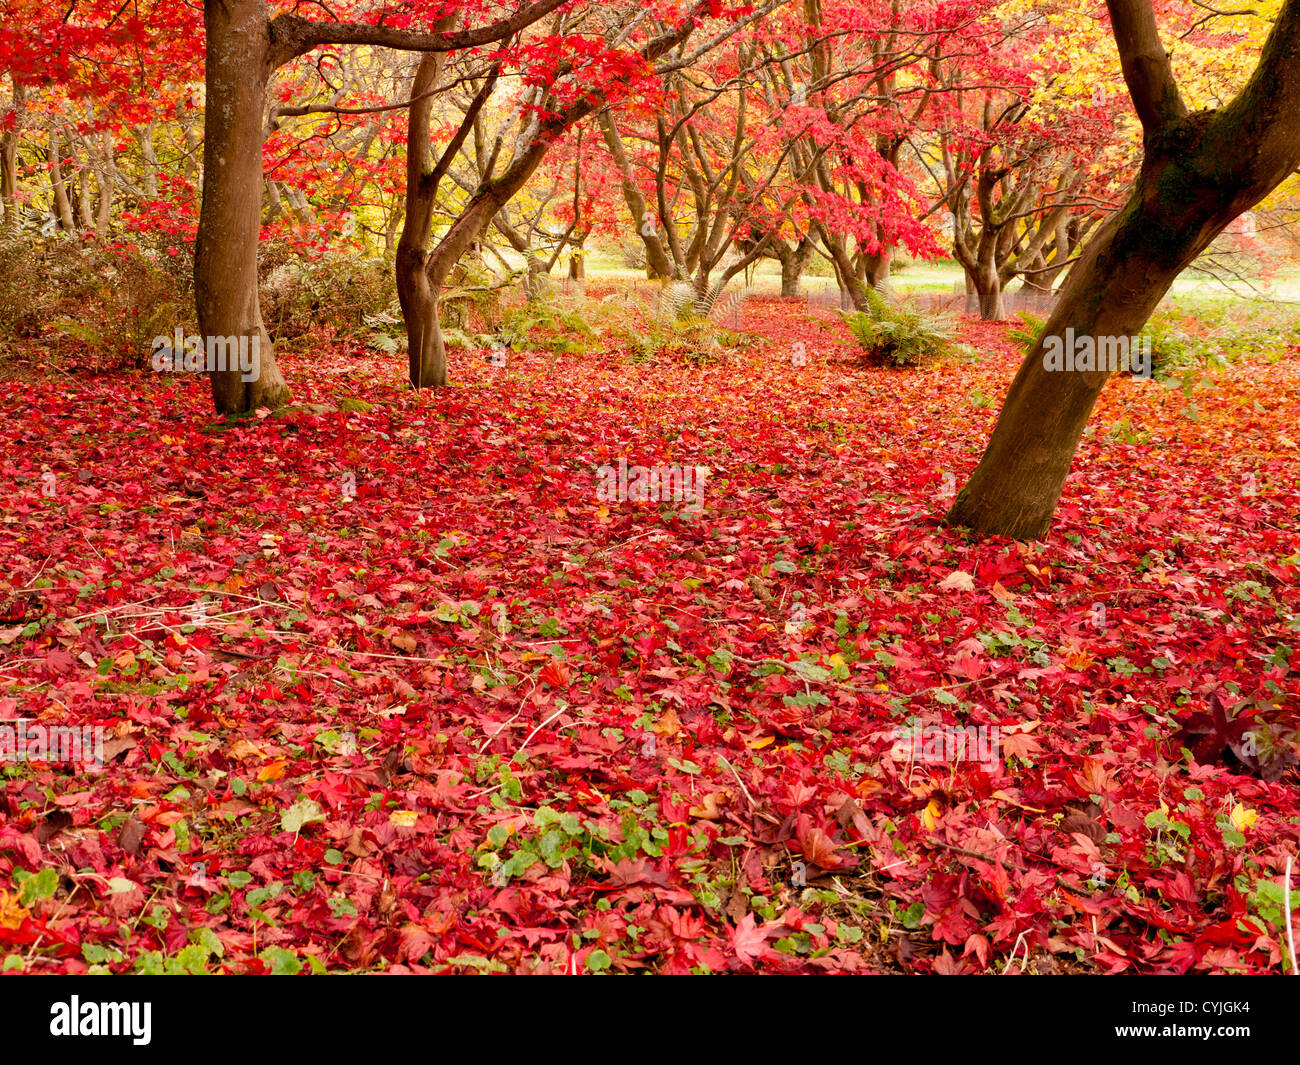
[{"x1": 948, "y1": 0, "x2": 1300, "y2": 540}]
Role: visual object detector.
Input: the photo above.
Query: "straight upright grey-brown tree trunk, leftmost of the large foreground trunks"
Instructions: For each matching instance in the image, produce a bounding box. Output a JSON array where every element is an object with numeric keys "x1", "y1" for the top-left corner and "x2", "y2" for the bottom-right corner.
[{"x1": 194, "y1": 0, "x2": 289, "y2": 414}]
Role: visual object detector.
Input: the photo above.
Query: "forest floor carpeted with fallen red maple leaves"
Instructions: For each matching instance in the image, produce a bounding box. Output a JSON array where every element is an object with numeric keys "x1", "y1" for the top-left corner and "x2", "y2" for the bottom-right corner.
[{"x1": 0, "y1": 300, "x2": 1300, "y2": 973}]
